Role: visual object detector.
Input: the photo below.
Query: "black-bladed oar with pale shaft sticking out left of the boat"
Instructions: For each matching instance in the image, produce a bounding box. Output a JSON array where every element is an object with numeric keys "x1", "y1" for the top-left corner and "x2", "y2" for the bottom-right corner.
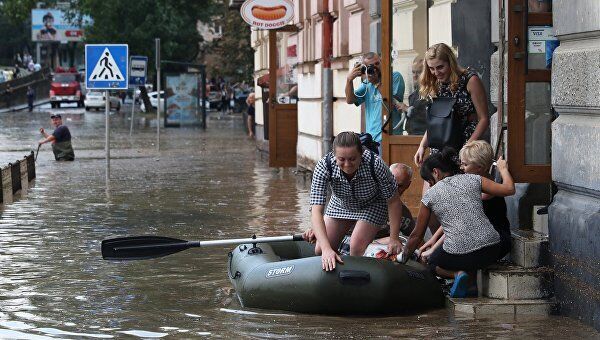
[{"x1": 102, "y1": 234, "x2": 303, "y2": 260}]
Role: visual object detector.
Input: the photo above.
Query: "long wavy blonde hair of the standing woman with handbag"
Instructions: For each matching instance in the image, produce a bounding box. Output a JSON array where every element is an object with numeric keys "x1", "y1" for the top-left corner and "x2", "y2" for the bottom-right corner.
[{"x1": 419, "y1": 43, "x2": 464, "y2": 98}]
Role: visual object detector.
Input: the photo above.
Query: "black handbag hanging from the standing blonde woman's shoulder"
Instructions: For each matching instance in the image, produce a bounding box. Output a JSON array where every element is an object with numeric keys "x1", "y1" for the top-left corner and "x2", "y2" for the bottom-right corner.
[{"x1": 427, "y1": 97, "x2": 462, "y2": 150}]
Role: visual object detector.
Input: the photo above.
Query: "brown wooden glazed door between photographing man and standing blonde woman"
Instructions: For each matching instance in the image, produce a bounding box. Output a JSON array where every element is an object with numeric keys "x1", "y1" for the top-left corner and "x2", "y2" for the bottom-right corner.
[{"x1": 381, "y1": 0, "x2": 428, "y2": 216}]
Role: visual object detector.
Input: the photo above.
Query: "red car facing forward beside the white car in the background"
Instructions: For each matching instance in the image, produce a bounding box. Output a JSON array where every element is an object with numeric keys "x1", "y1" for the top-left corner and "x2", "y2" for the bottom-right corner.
[{"x1": 50, "y1": 67, "x2": 85, "y2": 108}]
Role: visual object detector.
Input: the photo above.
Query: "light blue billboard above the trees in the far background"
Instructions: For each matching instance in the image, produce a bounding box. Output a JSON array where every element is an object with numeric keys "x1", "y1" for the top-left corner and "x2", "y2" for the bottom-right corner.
[{"x1": 31, "y1": 9, "x2": 91, "y2": 41}]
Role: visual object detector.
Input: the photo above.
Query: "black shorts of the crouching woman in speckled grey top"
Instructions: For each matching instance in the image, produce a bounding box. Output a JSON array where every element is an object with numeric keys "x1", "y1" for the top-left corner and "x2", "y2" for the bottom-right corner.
[{"x1": 428, "y1": 235, "x2": 510, "y2": 274}]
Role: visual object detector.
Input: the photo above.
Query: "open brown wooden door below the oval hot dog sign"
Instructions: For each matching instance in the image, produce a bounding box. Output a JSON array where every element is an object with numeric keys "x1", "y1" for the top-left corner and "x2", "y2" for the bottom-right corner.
[{"x1": 269, "y1": 26, "x2": 298, "y2": 167}]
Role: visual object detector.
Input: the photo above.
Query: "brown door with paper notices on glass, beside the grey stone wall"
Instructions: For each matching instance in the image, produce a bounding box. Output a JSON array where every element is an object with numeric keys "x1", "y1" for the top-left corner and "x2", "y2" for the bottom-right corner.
[{"x1": 506, "y1": 0, "x2": 558, "y2": 183}]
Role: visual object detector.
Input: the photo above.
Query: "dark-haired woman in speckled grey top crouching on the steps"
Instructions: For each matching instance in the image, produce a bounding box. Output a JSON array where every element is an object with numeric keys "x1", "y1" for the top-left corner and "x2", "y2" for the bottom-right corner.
[{"x1": 401, "y1": 148, "x2": 515, "y2": 297}]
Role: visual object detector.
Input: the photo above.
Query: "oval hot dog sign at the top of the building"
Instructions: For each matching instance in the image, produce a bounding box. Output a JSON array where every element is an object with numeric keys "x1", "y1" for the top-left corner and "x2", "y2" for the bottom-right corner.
[{"x1": 240, "y1": 0, "x2": 294, "y2": 30}]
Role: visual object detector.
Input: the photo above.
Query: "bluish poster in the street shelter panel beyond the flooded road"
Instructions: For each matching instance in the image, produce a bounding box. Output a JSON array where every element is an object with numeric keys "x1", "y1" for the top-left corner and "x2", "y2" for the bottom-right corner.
[{"x1": 165, "y1": 73, "x2": 201, "y2": 126}]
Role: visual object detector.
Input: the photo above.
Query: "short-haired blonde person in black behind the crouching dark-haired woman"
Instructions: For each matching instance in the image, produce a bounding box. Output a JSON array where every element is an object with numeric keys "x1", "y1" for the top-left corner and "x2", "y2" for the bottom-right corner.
[{"x1": 419, "y1": 140, "x2": 511, "y2": 263}]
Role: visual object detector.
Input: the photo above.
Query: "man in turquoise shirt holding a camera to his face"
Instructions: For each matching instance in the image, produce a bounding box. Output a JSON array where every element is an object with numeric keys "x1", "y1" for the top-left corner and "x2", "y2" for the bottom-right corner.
[{"x1": 345, "y1": 52, "x2": 404, "y2": 154}]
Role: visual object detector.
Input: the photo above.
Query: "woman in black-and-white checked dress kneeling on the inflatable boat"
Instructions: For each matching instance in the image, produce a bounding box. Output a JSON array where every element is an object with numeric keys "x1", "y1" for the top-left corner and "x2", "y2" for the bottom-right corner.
[{"x1": 305, "y1": 131, "x2": 402, "y2": 271}]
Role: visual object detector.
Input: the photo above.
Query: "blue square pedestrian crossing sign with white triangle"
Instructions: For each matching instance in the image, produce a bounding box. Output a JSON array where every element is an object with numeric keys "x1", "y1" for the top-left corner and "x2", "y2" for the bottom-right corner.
[{"x1": 85, "y1": 44, "x2": 129, "y2": 90}]
